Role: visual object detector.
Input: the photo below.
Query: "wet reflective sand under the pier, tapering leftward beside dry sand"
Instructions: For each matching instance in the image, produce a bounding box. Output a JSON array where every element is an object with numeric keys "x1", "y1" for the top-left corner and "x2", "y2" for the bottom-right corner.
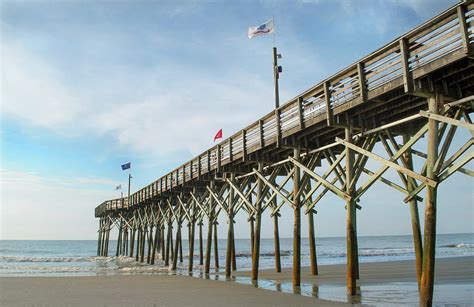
[{"x1": 135, "y1": 257, "x2": 474, "y2": 305}]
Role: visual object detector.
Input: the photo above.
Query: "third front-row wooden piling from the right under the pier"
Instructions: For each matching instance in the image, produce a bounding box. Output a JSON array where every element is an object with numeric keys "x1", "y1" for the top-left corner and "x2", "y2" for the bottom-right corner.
[{"x1": 292, "y1": 147, "x2": 301, "y2": 287}]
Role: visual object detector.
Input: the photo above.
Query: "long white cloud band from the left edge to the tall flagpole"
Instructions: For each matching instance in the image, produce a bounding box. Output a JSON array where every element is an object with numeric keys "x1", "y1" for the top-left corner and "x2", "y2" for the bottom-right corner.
[{"x1": 1, "y1": 38, "x2": 272, "y2": 159}]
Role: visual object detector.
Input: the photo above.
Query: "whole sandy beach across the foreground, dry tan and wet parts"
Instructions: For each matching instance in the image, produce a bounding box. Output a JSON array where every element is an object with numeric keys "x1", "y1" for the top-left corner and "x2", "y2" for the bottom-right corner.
[{"x1": 0, "y1": 257, "x2": 474, "y2": 306}]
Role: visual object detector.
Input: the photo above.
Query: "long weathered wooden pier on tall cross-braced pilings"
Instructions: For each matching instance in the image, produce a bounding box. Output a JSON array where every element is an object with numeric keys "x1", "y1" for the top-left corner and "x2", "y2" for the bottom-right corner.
[{"x1": 95, "y1": 1, "x2": 474, "y2": 306}]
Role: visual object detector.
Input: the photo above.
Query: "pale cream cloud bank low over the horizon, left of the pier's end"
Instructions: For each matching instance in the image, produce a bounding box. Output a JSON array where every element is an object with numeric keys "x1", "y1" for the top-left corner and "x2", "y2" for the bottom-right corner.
[{"x1": 0, "y1": 170, "x2": 116, "y2": 239}]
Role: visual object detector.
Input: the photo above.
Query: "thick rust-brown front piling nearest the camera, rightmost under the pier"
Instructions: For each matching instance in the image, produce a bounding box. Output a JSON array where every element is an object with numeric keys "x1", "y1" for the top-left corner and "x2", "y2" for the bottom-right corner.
[{"x1": 420, "y1": 93, "x2": 442, "y2": 306}]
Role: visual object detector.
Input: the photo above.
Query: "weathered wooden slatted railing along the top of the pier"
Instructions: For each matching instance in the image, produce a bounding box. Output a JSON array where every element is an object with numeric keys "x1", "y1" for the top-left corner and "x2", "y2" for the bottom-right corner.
[{"x1": 95, "y1": 3, "x2": 474, "y2": 216}]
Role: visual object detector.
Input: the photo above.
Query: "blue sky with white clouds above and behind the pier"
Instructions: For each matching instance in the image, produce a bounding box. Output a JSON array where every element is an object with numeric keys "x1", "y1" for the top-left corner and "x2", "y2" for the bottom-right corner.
[{"x1": 0, "y1": 0, "x2": 474, "y2": 239}]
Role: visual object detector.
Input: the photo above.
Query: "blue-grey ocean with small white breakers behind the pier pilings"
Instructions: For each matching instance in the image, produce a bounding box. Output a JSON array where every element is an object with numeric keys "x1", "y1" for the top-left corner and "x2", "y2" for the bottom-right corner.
[{"x1": 0, "y1": 233, "x2": 474, "y2": 276}]
